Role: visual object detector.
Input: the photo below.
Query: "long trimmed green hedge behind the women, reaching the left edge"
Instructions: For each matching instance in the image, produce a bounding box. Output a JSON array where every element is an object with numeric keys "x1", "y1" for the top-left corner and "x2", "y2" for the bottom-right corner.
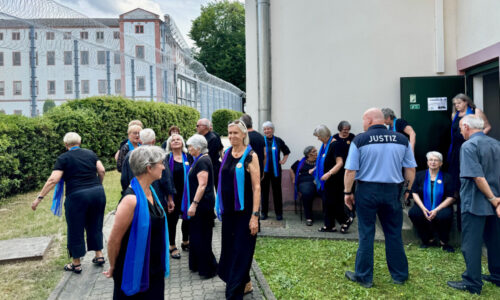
[{"x1": 0, "y1": 97, "x2": 200, "y2": 199}]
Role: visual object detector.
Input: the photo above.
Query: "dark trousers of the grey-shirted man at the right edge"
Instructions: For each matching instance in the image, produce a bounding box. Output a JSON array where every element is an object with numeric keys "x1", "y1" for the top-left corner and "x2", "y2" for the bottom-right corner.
[{"x1": 461, "y1": 213, "x2": 500, "y2": 292}]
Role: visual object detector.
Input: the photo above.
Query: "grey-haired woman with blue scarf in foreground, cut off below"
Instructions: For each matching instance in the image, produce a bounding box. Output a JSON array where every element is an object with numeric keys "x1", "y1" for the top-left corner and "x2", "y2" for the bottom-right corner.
[{"x1": 105, "y1": 146, "x2": 170, "y2": 299}]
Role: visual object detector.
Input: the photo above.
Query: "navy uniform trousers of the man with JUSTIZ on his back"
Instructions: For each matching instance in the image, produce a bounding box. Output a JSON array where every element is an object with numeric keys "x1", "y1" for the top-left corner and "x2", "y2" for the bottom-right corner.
[{"x1": 355, "y1": 181, "x2": 408, "y2": 283}]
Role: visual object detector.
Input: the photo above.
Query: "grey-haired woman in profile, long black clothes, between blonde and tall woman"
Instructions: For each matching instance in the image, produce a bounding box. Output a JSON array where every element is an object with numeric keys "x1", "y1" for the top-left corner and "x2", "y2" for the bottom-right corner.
[{"x1": 187, "y1": 134, "x2": 217, "y2": 278}]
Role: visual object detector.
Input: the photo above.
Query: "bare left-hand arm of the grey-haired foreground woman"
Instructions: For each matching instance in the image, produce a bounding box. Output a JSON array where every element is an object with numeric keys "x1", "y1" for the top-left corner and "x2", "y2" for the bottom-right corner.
[{"x1": 104, "y1": 195, "x2": 137, "y2": 278}]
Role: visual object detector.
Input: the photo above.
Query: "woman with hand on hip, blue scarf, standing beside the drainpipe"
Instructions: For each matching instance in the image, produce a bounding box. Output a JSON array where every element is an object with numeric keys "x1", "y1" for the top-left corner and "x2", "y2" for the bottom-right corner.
[{"x1": 261, "y1": 121, "x2": 290, "y2": 221}]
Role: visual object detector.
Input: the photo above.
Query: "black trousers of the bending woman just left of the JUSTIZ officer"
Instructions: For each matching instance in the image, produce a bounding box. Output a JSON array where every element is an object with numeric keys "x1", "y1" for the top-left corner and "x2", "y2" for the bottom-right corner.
[{"x1": 321, "y1": 178, "x2": 347, "y2": 228}]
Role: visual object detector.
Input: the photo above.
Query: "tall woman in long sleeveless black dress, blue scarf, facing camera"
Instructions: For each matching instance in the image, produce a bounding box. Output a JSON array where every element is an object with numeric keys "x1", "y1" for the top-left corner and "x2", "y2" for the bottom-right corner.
[{"x1": 215, "y1": 121, "x2": 260, "y2": 299}]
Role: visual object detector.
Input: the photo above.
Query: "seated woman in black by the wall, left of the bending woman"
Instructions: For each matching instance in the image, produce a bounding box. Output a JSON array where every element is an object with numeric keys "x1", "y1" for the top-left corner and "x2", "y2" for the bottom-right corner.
[{"x1": 292, "y1": 146, "x2": 318, "y2": 226}]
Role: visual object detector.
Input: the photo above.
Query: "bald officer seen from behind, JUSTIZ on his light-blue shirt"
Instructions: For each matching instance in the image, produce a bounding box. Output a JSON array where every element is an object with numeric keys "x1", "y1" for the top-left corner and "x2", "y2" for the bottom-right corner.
[{"x1": 344, "y1": 108, "x2": 417, "y2": 288}]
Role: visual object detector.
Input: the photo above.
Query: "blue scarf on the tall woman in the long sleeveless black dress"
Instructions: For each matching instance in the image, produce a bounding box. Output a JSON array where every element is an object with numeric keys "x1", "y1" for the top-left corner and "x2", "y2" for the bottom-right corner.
[{"x1": 215, "y1": 145, "x2": 252, "y2": 220}]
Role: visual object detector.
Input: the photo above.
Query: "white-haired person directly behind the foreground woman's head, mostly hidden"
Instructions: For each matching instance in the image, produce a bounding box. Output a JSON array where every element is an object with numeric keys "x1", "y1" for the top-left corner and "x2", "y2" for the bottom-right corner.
[{"x1": 120, "y1": 128, "x2": 176, "y2": 212}]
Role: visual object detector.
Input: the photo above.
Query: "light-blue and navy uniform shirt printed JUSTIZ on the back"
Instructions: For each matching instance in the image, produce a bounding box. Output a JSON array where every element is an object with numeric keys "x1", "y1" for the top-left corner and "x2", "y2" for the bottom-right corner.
[{"x1": 345, "y1": 125, "x2": 417, "y2": 183}]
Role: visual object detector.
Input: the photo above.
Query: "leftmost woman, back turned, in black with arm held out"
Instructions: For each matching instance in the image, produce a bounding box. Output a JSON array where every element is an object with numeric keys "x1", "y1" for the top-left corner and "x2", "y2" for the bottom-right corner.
[{"x1": 31, "y1": 132, "x2": 106, "y2": 273}]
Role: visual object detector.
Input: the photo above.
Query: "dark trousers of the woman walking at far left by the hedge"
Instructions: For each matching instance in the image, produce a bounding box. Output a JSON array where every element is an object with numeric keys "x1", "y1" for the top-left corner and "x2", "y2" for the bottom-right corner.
[{"x1": 64, "y1": 185, "x2": 106, "y2": 258}]
